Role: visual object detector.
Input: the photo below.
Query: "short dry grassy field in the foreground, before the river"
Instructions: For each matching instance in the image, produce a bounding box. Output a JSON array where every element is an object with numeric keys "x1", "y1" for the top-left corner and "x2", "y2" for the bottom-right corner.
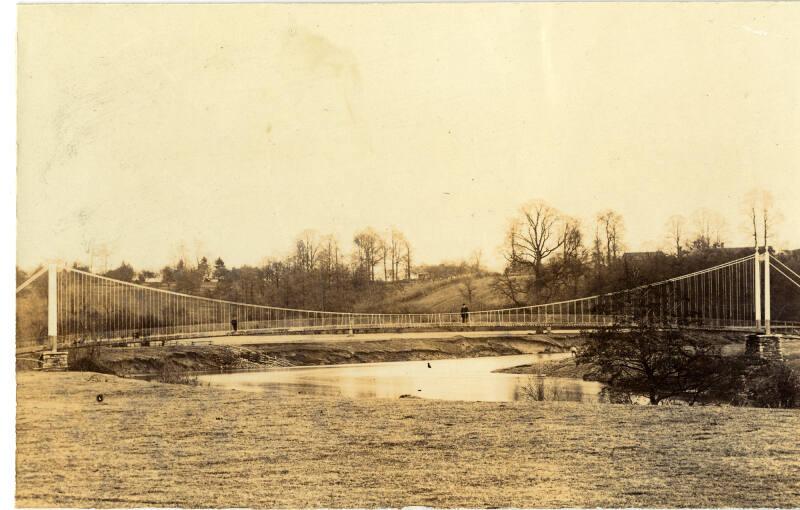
[{"x1": 16, "y1": 372, "x2": 800, "y2": 507}]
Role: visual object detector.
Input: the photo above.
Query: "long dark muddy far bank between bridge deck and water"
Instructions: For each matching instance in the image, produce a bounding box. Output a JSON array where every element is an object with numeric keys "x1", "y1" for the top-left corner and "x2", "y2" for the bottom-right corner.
[{"x1": 70, "y1": 335, "x2": 566, "y2": 375}]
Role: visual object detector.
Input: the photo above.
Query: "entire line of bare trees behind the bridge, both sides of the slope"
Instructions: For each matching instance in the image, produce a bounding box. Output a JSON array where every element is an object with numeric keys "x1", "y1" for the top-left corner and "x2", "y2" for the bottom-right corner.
[{"x1": 18, "y1": 193, "x2": 800, "y2": 320}]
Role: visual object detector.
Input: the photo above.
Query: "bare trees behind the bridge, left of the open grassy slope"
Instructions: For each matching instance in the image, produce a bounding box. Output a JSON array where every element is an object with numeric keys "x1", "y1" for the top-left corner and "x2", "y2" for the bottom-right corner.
[{"x1": 81, "y1": 227, "x2": 414, "y2": 311}]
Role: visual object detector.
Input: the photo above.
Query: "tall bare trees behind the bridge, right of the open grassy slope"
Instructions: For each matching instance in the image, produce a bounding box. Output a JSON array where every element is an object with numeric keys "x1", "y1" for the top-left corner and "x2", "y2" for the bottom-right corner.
[{"x1": 493, "y1": 195, "x2": 800, "y2": 320}]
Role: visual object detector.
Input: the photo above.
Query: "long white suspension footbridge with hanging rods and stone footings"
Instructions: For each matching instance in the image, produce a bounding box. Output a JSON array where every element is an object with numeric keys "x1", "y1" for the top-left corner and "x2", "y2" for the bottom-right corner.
[{"x1": 17, "y1": 248, "x2": 800, "y2": 367}]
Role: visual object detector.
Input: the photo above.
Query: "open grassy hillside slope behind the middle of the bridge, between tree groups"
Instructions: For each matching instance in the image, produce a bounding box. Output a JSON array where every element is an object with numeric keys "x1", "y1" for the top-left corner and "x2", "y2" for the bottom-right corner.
[{"x1": 356, "y1": 276, "x2": 506, "y2": 313}]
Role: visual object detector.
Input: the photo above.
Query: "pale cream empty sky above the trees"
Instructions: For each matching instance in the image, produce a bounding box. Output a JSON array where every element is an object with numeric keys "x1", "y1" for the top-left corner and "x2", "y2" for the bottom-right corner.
[{"x1": 17, "y1": 2, "x2": 800, "y2": 269}]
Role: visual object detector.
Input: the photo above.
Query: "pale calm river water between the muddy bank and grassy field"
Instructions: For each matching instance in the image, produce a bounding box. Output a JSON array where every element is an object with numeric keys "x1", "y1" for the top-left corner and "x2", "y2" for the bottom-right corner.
[{"x1": 199, "y1": 353, "x2": 602, "y2": 402}]
